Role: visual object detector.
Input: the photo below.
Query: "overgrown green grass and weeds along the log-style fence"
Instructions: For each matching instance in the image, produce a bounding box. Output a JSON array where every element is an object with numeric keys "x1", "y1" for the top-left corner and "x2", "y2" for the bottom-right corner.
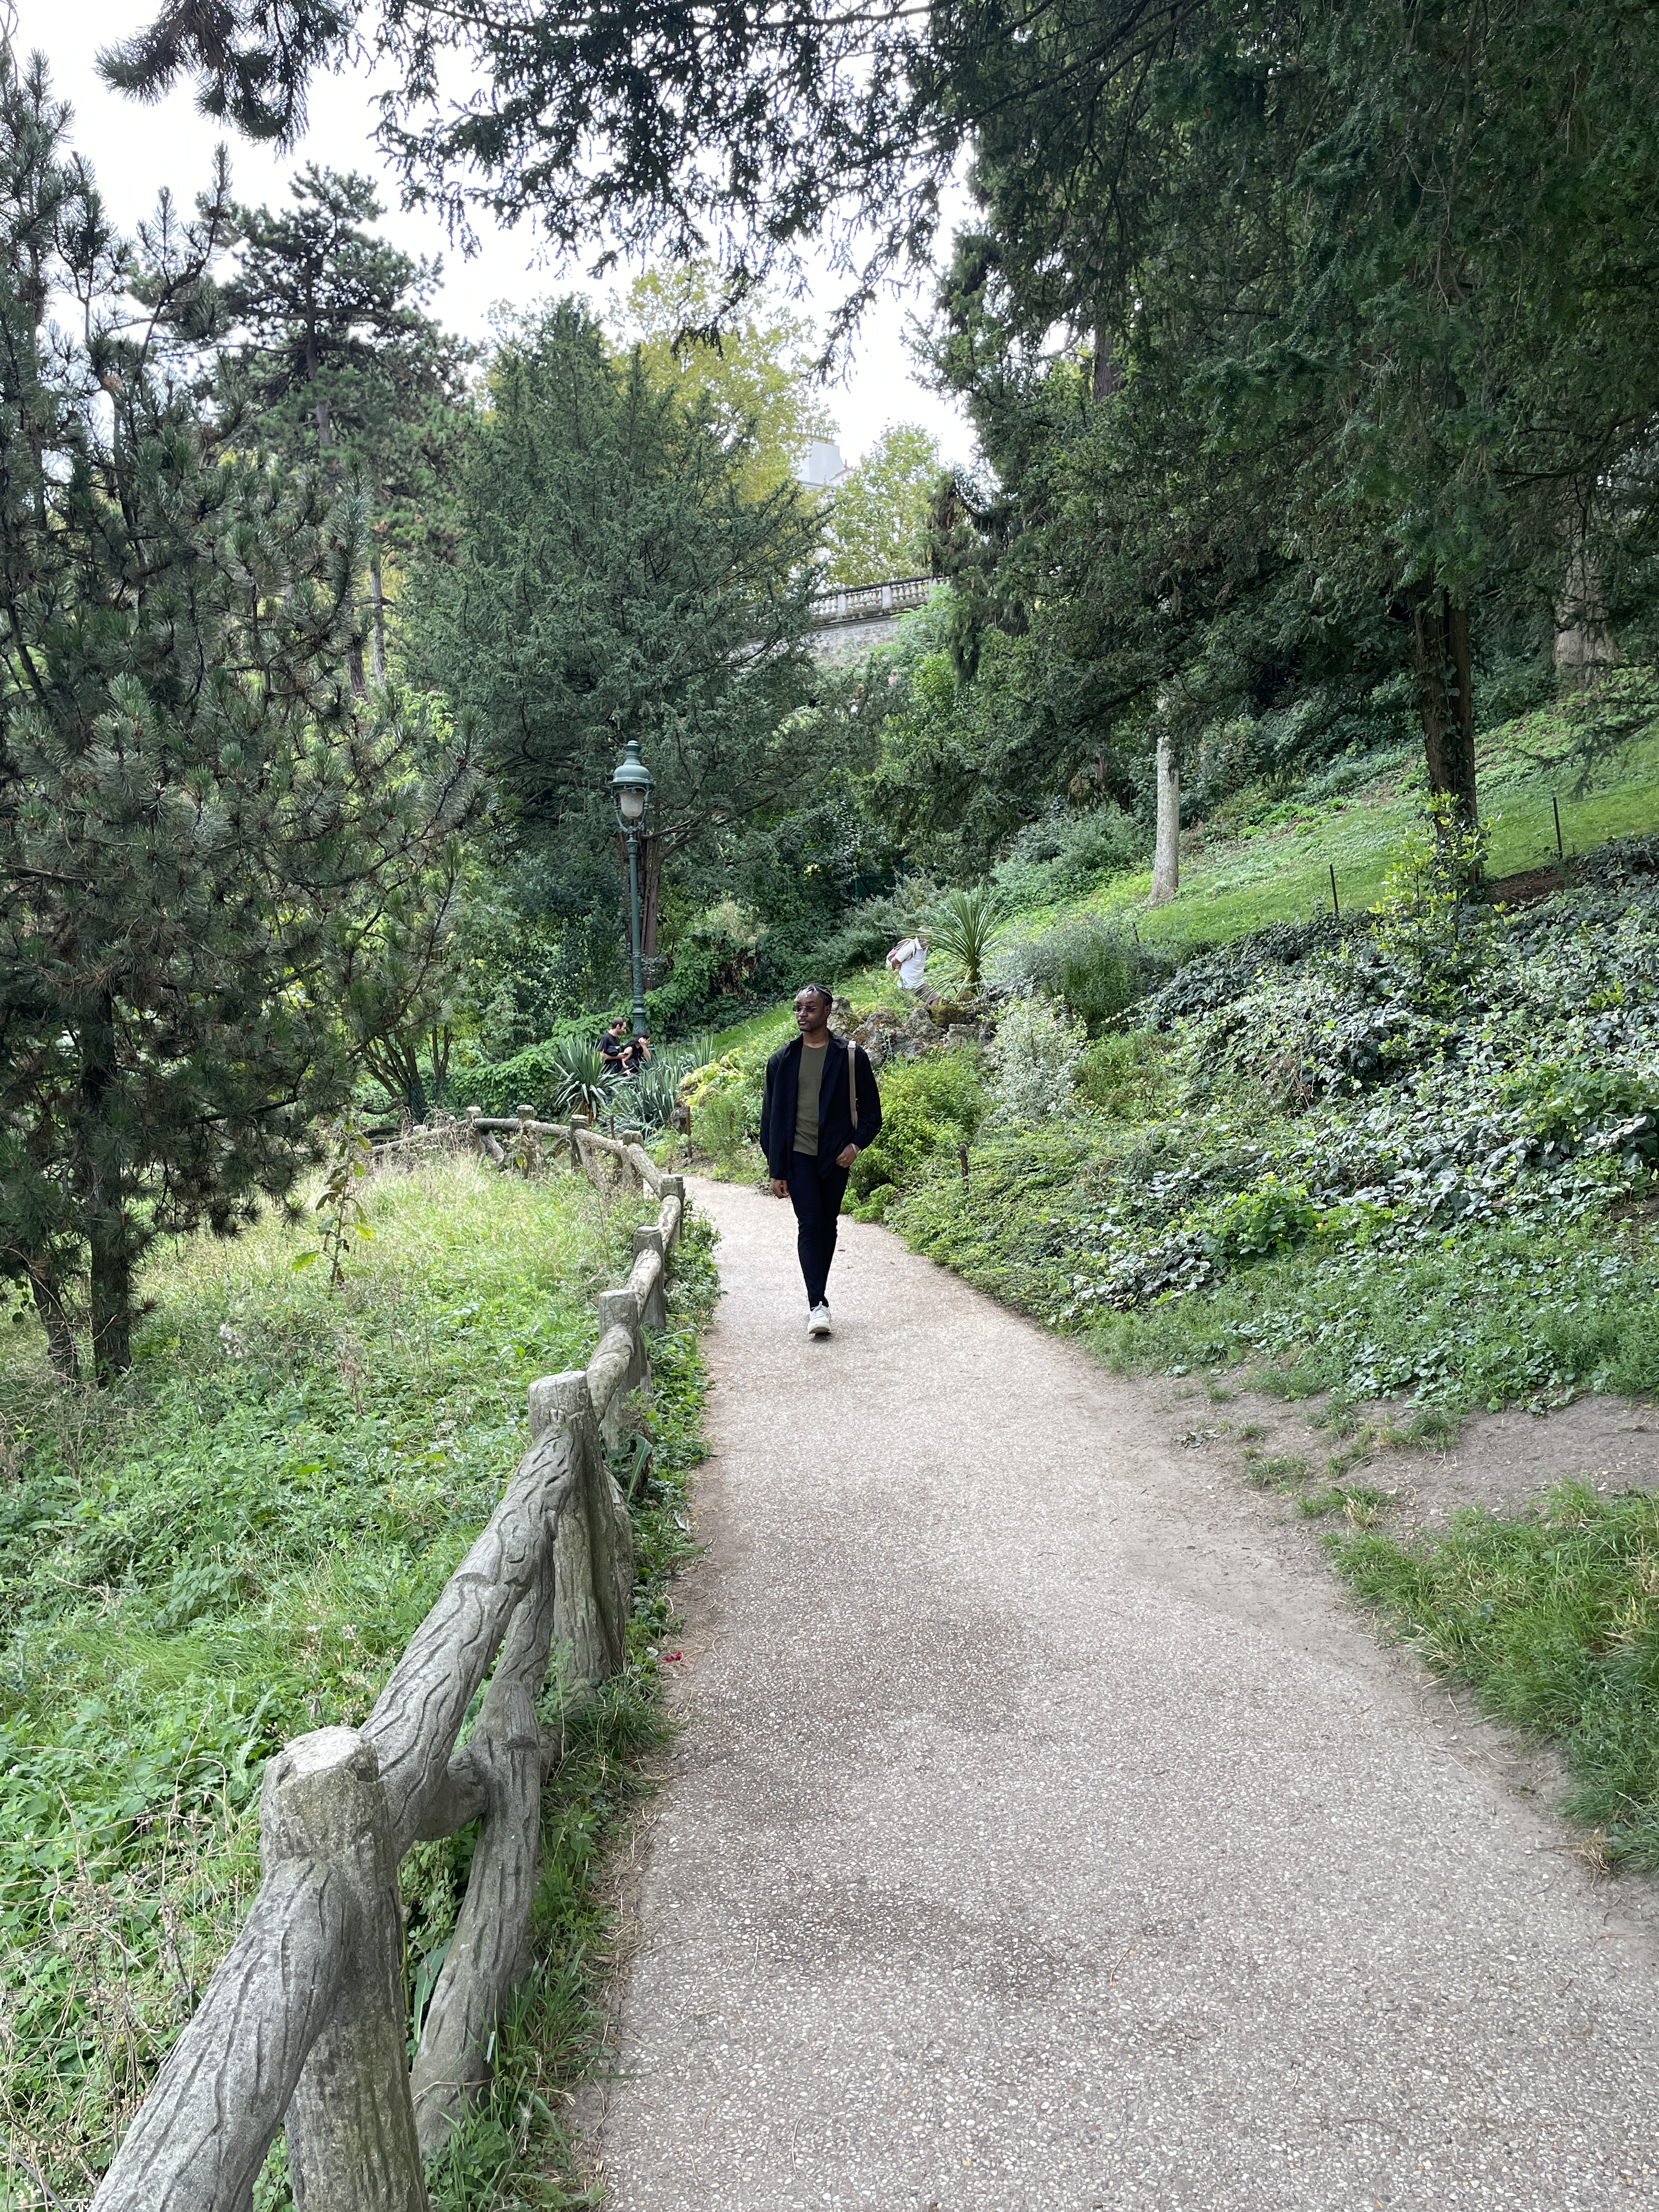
[{"x1": 0, "y1": 1161, "x2": 710, "y2": 2212}]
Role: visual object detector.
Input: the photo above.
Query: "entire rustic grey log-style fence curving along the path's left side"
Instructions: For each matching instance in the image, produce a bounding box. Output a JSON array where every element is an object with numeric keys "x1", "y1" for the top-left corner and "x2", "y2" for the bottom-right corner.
[{"x1": 93, "y1": 1110, "x2": 686, "y2": 2212}]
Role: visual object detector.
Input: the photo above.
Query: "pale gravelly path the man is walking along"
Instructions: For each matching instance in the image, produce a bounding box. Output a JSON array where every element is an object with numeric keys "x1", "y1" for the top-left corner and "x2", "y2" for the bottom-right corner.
[{"x1": 602, "y1": 1188, "x2": 1659, "y2": 2212}]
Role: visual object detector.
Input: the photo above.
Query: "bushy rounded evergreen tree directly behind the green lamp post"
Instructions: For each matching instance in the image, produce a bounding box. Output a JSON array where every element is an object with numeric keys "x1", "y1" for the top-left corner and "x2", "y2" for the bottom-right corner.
[{"x1": 411, "y1": 303, "x2": 819, "y2": 949}]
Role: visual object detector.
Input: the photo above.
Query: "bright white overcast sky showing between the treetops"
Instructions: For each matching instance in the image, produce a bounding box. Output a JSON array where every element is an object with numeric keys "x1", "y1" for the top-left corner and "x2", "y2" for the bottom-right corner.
[{"x1": 13, "y1": 0, "x2": 971, "y2": 462}]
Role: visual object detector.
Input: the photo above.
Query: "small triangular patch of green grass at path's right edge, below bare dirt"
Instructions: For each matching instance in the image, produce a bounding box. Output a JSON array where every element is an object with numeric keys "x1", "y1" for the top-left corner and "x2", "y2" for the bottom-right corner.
[{"x1": 1331, "y1": 1482, "x2": 1659, "y2": 1874}]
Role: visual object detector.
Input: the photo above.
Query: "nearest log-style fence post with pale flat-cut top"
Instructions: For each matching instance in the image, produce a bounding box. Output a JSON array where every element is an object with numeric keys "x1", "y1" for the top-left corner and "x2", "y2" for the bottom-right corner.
[{"x1": 259, "y1": 1728, "x2": 427, "y2": 2212}]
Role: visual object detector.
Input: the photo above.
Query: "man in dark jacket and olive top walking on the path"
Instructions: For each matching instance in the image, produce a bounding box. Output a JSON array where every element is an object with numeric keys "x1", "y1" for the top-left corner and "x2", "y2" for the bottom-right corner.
[{"x1": 761, "y1": 982, "x2": 881, "y2": 1336}]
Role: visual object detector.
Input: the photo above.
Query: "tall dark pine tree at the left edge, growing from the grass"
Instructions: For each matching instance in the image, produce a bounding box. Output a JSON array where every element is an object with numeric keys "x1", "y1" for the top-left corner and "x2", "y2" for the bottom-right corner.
[{"x1": 0, "y1": 49, "x2": 479, "y2": 1378}]
